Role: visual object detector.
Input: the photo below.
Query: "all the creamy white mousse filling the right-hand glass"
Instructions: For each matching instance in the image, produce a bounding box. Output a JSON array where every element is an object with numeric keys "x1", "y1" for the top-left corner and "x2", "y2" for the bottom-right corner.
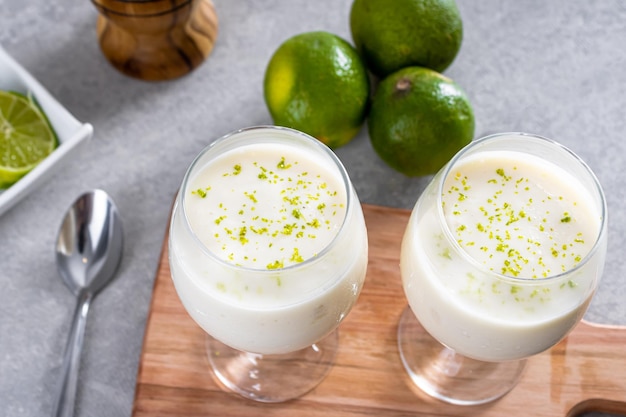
[{"x1": 401, "y1": 147, "x2": 604, "y2": 361}]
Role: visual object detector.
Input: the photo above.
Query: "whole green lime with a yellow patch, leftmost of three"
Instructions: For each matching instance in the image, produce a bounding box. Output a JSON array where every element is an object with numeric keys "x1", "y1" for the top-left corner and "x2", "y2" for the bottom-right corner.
[{"x1": 264, "y1": 31, "x2": 370, "y2": 148}]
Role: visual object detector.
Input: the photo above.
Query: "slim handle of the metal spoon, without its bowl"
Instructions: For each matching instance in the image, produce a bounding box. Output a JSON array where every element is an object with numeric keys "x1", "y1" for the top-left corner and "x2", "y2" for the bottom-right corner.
[{"x1": 52, "y1": 291, "x2": 93, "y2": 417}]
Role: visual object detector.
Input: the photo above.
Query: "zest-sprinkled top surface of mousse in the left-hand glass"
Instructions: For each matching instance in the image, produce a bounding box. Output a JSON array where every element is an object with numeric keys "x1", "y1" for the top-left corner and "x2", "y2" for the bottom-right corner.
[{"x1": 185, "y1": 144, "x2": 347, "y2": 269}]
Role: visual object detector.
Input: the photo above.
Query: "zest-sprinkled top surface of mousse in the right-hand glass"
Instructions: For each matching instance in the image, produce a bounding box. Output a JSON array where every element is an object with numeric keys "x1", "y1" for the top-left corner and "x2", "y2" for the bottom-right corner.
[{"x1": 442, "y1": 151, "x2": 601, "y2": 278}]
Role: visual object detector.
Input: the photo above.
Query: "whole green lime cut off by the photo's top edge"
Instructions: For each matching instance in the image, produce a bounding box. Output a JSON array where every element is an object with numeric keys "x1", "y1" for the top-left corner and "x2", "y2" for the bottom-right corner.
[{"x1": 350, "y1": 0, "x2": 463, "y2": 78}]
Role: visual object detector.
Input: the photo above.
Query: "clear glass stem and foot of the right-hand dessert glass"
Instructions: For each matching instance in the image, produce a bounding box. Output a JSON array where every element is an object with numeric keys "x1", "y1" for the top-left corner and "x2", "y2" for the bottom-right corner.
[{"x1": 398, "y1": 307, "x2": 526, "y2": 405}]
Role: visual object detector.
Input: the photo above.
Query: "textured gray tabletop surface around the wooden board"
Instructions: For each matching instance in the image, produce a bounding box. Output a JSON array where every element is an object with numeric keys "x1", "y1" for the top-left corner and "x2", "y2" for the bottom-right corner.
[{"x1": 0, "y1": 0, "x2": 626, "y2": 417}]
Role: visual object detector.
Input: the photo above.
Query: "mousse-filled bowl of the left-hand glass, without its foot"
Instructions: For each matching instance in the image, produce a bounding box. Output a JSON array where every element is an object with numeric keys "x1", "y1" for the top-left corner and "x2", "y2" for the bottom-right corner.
[{"x1": 170, "y1": 130, "x2": 367, "y2": 354}]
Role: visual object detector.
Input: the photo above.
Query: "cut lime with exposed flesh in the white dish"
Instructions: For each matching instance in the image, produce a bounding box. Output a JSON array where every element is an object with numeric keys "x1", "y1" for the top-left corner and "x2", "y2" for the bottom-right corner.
[{"x1": 0, "y1": 91, "x2": 58, "y2": 188}]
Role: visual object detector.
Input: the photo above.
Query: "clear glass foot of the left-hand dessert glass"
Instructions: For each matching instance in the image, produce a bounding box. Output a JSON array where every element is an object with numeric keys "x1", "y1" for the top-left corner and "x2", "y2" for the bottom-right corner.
[{"x1": 206, "y1": 329, "x2": 339, "y2": 403}]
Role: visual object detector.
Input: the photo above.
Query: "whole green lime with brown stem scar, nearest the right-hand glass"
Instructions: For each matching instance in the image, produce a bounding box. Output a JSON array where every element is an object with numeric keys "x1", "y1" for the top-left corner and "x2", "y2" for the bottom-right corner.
[{"x1": 368, "y1": 67, "x2": 474, "y2": 176}]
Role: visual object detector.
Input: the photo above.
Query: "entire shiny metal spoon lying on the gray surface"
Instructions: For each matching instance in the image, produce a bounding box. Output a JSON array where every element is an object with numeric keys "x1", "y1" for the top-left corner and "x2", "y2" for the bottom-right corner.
[{"x1": 52, "y1": 190, "x2": 123, "y2": 417}]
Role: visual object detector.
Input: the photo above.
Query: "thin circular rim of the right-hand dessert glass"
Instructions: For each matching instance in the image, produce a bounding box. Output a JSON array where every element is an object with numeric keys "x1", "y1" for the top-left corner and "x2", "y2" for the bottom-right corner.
[{"x1": 437, "y1": 132, "x2": 607, "y2": 285}]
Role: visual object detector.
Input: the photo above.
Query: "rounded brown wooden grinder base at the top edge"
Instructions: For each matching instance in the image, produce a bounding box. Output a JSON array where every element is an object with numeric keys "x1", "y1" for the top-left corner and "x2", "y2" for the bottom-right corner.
[{"x1": 92, "y1": 0, "x2": 218, "y2": 81}]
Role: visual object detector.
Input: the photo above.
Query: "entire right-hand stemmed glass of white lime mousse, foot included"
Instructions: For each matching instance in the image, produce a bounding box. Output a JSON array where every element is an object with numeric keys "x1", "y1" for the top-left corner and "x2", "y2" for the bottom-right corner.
[{"x1": 398, "y1": 133, "x2": 607, "y2": 405}]
